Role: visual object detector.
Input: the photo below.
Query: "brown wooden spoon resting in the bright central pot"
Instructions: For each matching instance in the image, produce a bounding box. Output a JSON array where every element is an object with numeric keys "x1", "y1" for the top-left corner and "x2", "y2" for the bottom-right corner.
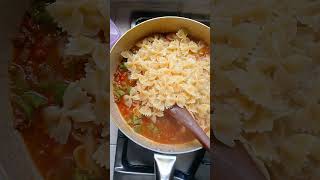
[{"x1": 165, "y1": 105, "x2": 210, "y2": 150}]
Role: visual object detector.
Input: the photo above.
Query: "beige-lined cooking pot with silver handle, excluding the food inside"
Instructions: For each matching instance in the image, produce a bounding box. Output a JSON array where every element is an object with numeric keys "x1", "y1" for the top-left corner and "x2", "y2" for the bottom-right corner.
[{"x1": 110, "y1": 16, "x2": 210, "y2": 179}]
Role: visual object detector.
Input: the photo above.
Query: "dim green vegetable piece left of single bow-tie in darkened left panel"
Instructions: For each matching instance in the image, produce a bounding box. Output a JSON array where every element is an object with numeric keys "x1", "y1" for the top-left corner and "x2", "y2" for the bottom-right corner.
[{"x1": 22, "y1": 91, "x2": 48, "y2": 109}]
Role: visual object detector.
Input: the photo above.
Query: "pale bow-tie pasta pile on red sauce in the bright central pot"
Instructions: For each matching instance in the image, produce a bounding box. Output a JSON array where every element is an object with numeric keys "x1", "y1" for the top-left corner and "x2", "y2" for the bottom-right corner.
[{"x1": 121, "y1": 30, "x2": 210, "y2": 128}]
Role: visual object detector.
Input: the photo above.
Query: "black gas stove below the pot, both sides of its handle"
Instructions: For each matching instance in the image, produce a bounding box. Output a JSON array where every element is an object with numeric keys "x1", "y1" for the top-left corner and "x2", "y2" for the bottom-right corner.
[{"x1": 113, "y1": 131, "x2": 211, "y2": 180}]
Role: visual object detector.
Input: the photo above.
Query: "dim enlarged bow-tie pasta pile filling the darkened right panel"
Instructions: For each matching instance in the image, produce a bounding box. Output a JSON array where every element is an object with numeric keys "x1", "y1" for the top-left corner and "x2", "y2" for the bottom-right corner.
[{"x1": 212, "y1": 0, "x2": 320, "y2": 180}]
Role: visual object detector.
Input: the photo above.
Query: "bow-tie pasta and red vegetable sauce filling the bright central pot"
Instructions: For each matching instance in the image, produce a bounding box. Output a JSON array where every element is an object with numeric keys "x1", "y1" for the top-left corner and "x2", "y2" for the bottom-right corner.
[{"x1": 113, "y1": 29, "x2": 210, "y2": 143}]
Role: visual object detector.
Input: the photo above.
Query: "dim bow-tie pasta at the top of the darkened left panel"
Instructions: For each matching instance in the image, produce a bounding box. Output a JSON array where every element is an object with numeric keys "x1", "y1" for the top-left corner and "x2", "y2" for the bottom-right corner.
[{"x1": 47, "y1": 0, "x2": 107, "y2": 36}]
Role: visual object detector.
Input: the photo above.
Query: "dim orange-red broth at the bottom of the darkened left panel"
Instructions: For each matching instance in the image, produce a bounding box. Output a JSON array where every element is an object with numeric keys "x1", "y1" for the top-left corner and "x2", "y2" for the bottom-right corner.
[{"x1": 20, "y1": 114, "x2": 79, "y2": 180}]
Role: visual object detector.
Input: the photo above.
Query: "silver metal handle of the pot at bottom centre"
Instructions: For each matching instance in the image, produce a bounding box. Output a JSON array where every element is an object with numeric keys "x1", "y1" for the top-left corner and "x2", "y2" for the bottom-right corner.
[{"x1": 154, "y1": 154, "x2": 177, "y2": 180}]
